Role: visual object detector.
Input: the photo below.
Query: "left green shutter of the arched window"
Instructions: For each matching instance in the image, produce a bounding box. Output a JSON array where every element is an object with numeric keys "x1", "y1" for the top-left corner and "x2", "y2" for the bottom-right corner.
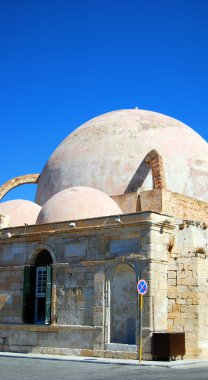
[{"x1": 22, "y1": 266, "x2": 35, "y2": 323}]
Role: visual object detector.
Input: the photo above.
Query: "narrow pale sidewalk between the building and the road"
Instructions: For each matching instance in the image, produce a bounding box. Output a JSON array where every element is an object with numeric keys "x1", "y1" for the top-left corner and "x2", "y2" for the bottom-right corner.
[{"x1": 0, "y1": 352, "x2": 208, "y2": 368}]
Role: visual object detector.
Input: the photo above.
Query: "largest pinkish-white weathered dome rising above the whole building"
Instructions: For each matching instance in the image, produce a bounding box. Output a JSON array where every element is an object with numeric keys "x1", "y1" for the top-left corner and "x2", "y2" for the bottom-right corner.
[{"x1": 36, "y1": 109, "x2": 208, "y2": 205}]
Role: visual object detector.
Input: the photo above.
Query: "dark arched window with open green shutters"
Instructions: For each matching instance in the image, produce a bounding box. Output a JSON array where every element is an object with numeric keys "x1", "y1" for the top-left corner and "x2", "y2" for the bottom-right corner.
[{"x1": 23, "y1": 250, "x2": 52, "y2": 324}]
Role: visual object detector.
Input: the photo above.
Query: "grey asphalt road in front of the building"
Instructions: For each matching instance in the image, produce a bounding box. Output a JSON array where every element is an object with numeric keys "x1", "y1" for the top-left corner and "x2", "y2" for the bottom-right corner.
[{"x1": 0, "y1": 357, "x2": 208, "y2": 380}]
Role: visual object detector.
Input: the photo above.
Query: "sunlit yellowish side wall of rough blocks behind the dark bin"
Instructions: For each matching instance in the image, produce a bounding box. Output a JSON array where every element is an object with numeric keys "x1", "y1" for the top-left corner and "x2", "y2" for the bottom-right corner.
[{"x1": 168, "y1": 220, "x2": 208, "y2": 357}]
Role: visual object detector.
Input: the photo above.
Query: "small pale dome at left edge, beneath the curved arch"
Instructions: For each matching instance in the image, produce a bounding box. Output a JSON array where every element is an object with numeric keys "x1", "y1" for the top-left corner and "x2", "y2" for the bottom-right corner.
[{"x1": 0, "y1": 199, "x2": 41, "y2": 227}]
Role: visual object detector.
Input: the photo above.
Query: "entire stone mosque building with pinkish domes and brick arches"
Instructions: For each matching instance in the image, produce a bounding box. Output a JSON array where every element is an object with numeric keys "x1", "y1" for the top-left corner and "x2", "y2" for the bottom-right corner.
[{"x1": 0, "y1": 109, "x2": 208, "y2": 360}]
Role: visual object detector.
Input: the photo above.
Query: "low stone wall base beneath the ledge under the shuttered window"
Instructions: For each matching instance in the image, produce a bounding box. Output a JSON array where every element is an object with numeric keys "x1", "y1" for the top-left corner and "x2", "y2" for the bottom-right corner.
[{"x1": 0, "y1": 324, "x2": 102, "y2": 355}]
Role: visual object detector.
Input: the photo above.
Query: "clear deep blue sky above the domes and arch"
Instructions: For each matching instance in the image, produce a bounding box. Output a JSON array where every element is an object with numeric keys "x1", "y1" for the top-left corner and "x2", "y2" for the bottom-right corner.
[{"x1": 0, "y1": 0, "x2": 208, "y2": 201}]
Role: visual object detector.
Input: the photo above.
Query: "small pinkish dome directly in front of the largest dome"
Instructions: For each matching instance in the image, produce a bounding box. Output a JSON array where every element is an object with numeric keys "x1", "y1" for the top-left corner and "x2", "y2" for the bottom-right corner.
[{"x1": 36, "y1": 186, "x2": 122, "y2": 224}]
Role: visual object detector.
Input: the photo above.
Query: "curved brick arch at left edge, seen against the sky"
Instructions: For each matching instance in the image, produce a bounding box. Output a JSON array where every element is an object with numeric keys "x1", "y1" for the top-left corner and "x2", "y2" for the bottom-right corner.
[{"x1": 0, "y1": 174, "x2": 40, "y2": 200}]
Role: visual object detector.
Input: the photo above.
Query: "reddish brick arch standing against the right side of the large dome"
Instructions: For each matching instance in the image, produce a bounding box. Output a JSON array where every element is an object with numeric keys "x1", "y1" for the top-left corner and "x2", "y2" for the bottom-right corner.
[{"x1": 144, "y1": 149, "x2": 166, "y2": 189}]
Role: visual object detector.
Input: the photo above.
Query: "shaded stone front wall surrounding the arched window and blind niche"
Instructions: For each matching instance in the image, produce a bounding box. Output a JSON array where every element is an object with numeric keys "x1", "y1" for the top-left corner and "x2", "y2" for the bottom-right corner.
[{"x1": 0, "y1": 213, "x2": 173, "y2": 359}]
